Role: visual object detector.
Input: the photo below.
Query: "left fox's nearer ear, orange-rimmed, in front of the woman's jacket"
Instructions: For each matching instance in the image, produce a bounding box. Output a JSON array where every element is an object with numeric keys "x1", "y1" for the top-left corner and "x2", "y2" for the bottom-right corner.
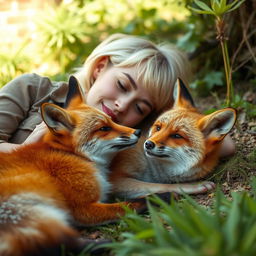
[{"x1": 41, "y1": 103, "x2": 74, "y2": 135}]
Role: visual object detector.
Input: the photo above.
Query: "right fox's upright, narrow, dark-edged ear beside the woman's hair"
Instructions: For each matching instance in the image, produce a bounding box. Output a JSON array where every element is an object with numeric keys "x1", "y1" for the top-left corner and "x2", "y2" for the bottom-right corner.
[{"x1": 173, "y1": 78, "x2": 195, "y2": 108}]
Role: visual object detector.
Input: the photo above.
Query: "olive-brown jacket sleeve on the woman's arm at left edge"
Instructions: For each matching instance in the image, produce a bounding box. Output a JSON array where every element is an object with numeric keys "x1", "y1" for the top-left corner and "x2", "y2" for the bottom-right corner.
[{"x1": 0, "y1": 74, "x2": 43, "y2": 143}]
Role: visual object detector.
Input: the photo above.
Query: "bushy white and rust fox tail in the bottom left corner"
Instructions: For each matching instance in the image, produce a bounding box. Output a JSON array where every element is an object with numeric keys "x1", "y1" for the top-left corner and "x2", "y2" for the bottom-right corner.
[{"x1": 0, "y1": 193, "x2": 81, "y2": 256}]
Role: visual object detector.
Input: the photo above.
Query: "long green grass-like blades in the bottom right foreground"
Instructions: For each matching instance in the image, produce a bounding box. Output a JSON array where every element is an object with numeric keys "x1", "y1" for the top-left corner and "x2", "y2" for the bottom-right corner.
[{"x1": 110, "y1": 178, "x2": 256, "y2": 256}]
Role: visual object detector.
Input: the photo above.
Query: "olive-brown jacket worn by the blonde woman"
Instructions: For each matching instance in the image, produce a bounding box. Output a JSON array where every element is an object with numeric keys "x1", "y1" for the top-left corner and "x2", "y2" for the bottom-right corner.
[{"x1": 0, "y1": 74, "x2": 68, "y2": 144}]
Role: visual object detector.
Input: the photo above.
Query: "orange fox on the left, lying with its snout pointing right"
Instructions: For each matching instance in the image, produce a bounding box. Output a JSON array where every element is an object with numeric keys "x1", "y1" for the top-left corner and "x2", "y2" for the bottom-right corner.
[{"x1": 0, "y1": 82, "x2": 145, "y2": 256}]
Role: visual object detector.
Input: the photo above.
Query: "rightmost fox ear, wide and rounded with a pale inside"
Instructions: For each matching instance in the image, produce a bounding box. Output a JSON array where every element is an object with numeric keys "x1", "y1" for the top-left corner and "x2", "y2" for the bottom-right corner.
[{"x1": 199, "y1": 108, "x2": 237, "y2": 141}]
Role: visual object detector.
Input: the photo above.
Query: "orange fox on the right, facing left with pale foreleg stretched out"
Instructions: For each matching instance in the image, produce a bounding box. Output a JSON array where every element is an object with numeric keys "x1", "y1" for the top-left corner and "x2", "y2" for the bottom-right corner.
[{"x1": 110, "y1": 79, "x2": 236, "y2": 198}]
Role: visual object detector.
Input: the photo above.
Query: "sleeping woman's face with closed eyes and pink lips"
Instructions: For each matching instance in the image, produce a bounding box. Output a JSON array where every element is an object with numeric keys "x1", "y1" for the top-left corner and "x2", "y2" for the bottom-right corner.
[{"x1": 86, "y1": 63, "x2": 154, "y2": 127}]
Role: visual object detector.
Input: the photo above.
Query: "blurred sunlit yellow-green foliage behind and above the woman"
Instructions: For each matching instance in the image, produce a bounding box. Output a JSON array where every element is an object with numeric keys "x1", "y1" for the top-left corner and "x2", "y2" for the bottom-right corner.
[{"x1": 0, "y1": 0, "x2": 189, "y2": 85}]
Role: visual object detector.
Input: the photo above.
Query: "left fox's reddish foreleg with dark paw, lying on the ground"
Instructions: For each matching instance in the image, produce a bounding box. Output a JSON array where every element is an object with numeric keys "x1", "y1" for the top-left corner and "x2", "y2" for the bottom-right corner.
[{"x1": 72, "y1": 198, "x2": 146, "y2": 225}]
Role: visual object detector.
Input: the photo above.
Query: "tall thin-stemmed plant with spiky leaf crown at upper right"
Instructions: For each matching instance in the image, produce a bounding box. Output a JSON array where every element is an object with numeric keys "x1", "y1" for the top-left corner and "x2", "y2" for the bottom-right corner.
[{"x1": 190, "y1": 0, "x2": 245, "y2": 106}]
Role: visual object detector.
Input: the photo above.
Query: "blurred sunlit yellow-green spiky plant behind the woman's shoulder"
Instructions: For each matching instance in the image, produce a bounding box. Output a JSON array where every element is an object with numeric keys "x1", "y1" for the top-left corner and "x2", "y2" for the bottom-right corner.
[{"x1": 36, "y1": 2, "x2": 89, "y2": 73}]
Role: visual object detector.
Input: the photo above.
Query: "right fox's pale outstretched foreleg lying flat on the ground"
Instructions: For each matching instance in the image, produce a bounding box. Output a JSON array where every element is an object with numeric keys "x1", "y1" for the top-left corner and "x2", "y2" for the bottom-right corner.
[{"x1": 113, "y1": 178, "x2": 215, "y2": 198}]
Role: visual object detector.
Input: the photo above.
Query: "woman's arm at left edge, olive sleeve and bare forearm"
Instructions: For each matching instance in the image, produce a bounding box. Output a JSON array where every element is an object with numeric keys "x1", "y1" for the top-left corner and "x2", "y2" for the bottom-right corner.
[{"x1": 0, "y1": 74, "x2": 49, "y2": 151}]
